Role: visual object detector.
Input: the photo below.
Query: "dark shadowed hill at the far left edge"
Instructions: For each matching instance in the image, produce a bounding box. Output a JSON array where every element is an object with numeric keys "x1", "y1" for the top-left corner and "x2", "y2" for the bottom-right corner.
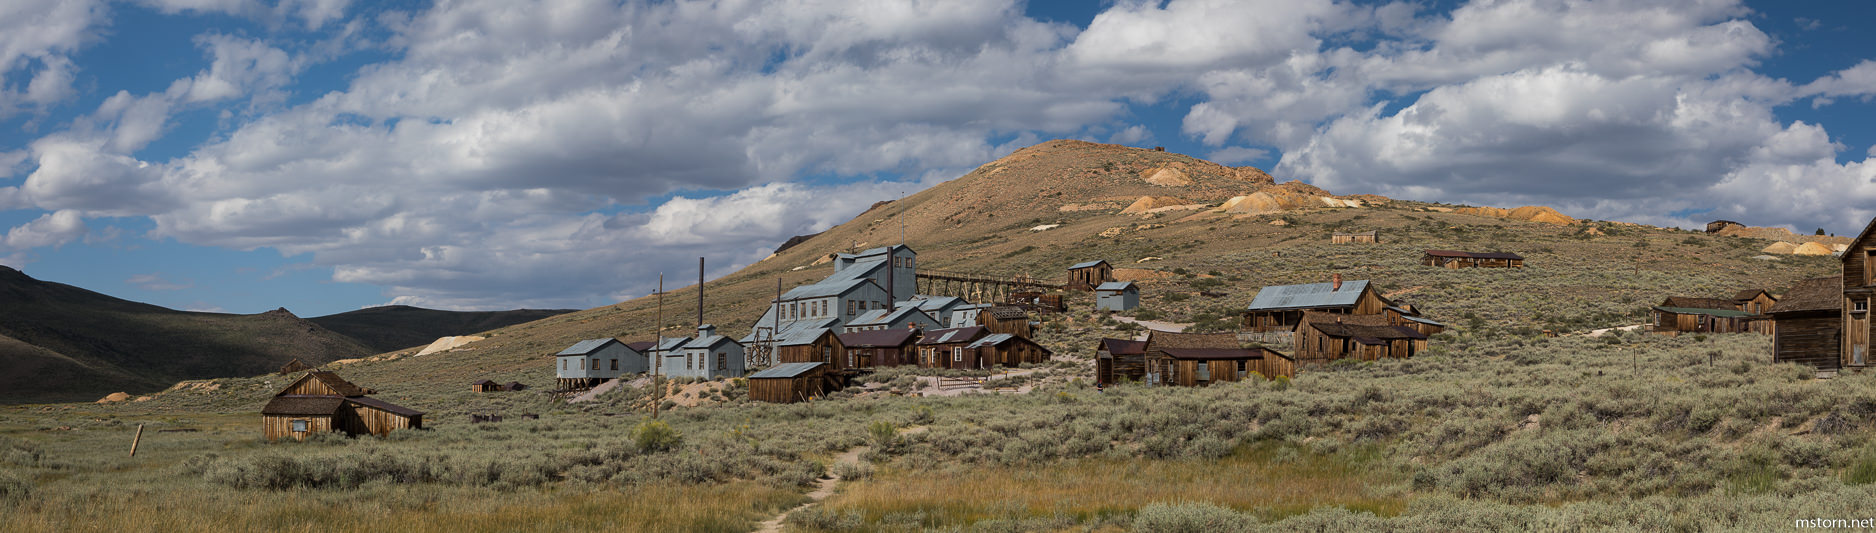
[{"x1": 0, "y1": 267, "x2": 377, "y2": 404}]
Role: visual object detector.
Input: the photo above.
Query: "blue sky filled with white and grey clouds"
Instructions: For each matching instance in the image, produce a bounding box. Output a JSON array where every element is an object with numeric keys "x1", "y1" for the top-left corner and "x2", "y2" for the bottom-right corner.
[{"x1": 0, "y1": 0, "x2": 1876, "y2": 317}]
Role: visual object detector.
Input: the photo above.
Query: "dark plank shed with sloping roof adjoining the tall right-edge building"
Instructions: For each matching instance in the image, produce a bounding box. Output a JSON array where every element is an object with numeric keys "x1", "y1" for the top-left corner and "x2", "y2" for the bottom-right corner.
[{"x1": 1769, "y1": 276, "x2": 1844, "y2": 370}]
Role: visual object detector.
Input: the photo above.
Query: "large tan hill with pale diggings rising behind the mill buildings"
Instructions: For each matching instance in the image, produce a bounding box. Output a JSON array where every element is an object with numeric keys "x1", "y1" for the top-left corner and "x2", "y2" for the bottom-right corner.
[{"x1": 102, "y1": 141, "x2": 1837, "y2": 413}]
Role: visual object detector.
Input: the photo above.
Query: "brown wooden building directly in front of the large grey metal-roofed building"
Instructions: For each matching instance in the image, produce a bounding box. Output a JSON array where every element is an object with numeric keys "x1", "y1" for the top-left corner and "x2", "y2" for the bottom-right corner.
[{"x1": 1294, "y1": 312, "x2": 1426, "y2": 362}]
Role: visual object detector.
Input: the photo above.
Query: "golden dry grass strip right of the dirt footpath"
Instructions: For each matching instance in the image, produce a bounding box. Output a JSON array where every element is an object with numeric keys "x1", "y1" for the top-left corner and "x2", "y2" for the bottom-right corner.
[{"x1": 824, "y1": 445, "x2": 1407, "y2": 527}]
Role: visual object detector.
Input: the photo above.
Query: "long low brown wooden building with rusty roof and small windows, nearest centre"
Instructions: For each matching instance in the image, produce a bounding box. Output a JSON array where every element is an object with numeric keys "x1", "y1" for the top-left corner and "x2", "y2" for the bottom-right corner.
[{"x1": 1142, "y1": 330, "x2": 1296, "y2": 387}]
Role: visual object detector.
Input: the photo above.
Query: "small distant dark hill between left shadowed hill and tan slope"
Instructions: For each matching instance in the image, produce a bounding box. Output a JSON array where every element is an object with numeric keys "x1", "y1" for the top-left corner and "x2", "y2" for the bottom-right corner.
[{"x1": 308, "y1": 306, "x2": 576, "y2": 351}]
